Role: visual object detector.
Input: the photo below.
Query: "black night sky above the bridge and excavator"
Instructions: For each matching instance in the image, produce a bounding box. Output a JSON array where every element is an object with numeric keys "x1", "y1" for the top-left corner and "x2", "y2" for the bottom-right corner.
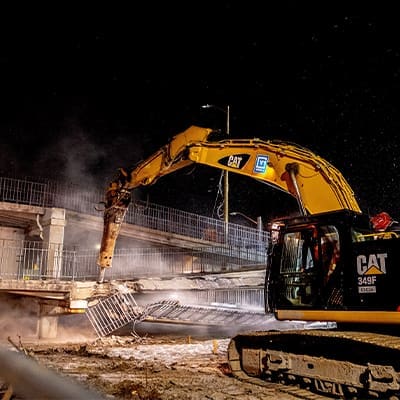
[{"x1": 0, "y1": 1, "x2": 400, "y2": 222}]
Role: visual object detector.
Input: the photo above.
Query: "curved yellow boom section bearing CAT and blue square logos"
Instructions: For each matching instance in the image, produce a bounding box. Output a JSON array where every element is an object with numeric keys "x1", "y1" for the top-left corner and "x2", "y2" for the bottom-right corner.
[{"x1": 187, "y1": 139, "x2": 360, "y2": 215}]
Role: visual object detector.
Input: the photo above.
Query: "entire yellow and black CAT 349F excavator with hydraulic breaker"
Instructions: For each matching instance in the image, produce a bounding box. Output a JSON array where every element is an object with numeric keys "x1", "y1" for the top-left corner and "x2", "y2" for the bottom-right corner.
[{"x1": 98, "y1": 126, "x2": 400, "y2": 400}]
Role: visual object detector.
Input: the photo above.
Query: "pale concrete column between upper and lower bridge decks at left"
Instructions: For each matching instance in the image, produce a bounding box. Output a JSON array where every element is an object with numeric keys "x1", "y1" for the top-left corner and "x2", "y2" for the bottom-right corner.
[{"x1": 41, "y1": 208, "x2": 66, "y2": 278}]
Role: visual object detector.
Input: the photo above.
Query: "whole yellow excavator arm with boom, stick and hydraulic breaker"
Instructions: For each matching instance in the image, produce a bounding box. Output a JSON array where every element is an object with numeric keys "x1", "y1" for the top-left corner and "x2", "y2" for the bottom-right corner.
[{"x1": 98, "y1": 126, "x2": 361, "y2": 281}]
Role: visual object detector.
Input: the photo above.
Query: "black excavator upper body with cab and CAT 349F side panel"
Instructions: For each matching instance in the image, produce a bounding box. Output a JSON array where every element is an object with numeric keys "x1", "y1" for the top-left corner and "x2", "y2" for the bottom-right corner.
[{"x1": 265, "y1": 210, "x2": 400, "y2": 324}]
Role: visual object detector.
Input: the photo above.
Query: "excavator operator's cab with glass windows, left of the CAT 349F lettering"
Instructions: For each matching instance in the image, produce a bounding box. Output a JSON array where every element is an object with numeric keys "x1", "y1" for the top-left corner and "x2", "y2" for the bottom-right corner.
[{"x1": 271, "y1": 216, "x2": 340, "y2": 309}]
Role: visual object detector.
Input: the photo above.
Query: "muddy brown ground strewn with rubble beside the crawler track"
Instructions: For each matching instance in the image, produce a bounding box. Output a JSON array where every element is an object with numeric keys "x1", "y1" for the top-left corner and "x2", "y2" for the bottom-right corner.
[{"x1": 2, "y1": 336, "x2": 318, "y2": 400}]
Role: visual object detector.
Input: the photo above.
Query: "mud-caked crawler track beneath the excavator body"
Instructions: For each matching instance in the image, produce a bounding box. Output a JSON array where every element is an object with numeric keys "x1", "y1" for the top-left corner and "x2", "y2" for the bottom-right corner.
[{"x1": 228, "y1": 330, "x2": 400, "y2": 400}]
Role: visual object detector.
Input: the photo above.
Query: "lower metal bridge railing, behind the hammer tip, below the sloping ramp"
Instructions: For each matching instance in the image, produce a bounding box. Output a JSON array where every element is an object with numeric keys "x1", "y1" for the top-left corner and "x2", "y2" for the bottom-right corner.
[{"x1": 0, "y1": 240, "x2": 266, "y2": 281}]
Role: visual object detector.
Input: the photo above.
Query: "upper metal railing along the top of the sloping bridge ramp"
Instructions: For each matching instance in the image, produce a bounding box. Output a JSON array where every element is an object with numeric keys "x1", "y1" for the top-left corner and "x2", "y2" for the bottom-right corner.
[{"x1": 0, "y1": 177, "x2": 268, "y2": 251}]
